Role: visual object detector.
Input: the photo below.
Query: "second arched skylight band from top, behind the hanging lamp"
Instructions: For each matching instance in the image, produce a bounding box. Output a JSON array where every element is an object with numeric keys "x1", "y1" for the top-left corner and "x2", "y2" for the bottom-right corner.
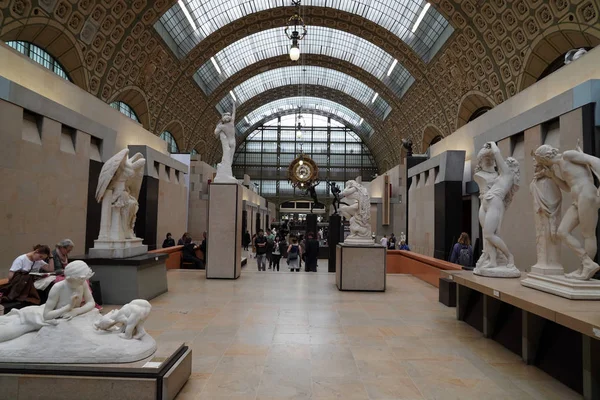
[{"x1": 194, "y1": 26, "x2": 412, "y2": 96}]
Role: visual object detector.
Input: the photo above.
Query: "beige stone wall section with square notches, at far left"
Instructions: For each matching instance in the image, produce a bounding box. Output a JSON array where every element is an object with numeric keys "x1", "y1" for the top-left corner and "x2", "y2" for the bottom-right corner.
[{"x1": 0, "y1": 100, "x2": 93, "y2": 278}]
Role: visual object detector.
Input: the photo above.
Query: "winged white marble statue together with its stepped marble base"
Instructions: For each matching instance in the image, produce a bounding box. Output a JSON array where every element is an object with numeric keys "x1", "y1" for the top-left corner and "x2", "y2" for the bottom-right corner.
[{"x1": 90, "y1": 149, "x2": 148, "y2": 258}]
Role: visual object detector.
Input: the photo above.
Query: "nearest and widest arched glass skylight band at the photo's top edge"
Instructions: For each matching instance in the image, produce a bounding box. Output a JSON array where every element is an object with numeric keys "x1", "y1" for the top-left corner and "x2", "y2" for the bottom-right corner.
[{"x1": 155, "y1": 0, "x2": 452, "y2": 61}]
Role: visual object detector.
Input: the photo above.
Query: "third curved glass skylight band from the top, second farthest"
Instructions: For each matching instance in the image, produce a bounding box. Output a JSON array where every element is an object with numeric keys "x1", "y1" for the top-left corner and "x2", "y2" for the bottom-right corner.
[{"x1": 217, "y1": 65, "x2": 391, "y2": 120}]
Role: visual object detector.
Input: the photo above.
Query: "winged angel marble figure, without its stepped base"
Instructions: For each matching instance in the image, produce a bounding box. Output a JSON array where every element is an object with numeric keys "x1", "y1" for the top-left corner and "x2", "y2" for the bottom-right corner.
[{"x1": 96, "y1": 149, "x2": 146, "y2": 241}]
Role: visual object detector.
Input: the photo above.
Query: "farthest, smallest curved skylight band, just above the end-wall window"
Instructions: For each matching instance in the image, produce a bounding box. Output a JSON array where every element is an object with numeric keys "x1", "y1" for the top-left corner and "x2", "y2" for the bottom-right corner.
[{"x1": 236, "y1": 96, "x2": 373, "y2": 138}]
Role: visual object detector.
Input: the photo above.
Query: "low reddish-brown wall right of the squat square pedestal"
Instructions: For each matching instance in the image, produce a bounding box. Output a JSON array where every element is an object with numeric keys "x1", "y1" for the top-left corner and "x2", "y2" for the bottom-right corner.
[{"x1": 387, "y1": 250, "x2": 462, "y2": 287}]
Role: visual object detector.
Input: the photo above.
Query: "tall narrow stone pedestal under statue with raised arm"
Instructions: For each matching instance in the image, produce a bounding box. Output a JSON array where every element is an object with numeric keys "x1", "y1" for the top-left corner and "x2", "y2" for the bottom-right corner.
[{"x1": 206, "y1": 183, "x2": 242, "y2": 279}]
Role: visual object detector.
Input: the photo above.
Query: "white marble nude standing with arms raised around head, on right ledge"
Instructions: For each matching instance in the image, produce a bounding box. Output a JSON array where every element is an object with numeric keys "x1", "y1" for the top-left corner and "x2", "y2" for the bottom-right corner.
[{"x1": 473, "y1": 142, "x2": 521, "y2": 278}]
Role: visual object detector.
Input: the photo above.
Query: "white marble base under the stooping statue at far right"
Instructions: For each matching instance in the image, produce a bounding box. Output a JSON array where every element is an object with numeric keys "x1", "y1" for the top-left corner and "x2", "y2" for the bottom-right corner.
[{"x1": 521, "y1": 273, "x2": 600, "y2": 300}]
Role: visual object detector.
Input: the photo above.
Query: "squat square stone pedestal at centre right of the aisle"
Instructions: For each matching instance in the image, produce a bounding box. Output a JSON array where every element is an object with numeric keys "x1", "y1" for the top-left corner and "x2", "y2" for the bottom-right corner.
[{"x1": 335, "y1": 243, "x2": 387, "y2": 292}]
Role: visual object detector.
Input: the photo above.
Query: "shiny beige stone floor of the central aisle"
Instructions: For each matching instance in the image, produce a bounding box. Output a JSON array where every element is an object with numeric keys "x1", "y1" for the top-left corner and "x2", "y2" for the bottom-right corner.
[{"x1": 141, "y1": 268, "x2": 581, "y2": 400}]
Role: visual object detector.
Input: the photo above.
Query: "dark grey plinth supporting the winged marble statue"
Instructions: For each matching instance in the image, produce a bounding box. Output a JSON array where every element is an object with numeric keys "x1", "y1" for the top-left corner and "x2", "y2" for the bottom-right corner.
[{"x1": 72, "y1": 254, "x2": 169, "y2": 305}]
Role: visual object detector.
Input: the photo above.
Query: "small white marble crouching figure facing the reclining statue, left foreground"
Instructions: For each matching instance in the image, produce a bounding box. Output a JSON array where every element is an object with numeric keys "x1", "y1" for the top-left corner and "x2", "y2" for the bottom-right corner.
[{"x1": 94, "y1": 299, "x2": 152, "y2": 340}]
